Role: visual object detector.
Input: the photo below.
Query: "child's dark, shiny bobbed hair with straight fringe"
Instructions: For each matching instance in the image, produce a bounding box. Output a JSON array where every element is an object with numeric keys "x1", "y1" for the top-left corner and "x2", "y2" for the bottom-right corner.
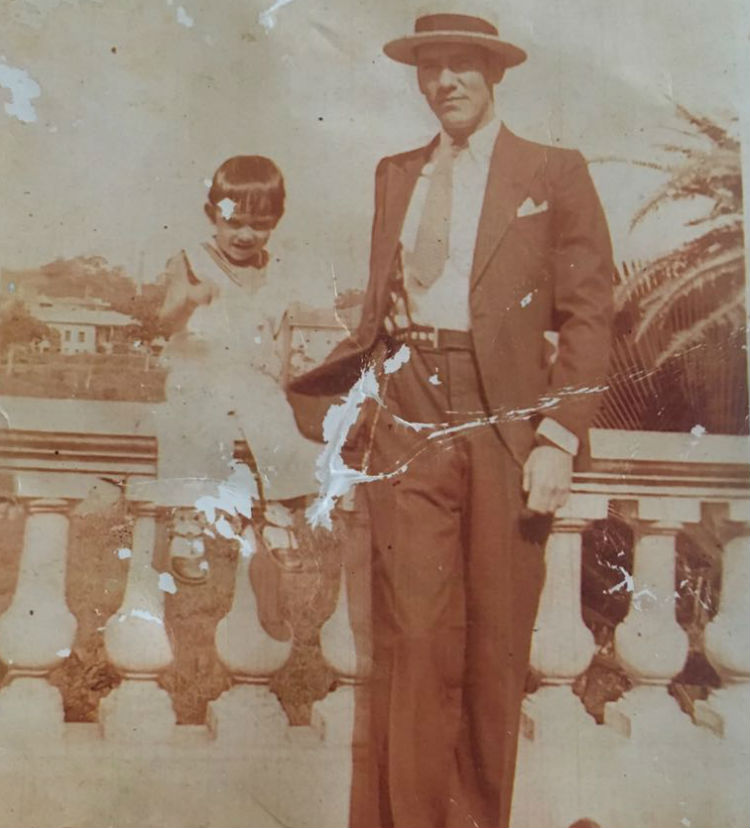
[{"x1": 208, "y1": 155, "x2": 286, "y2": 219}]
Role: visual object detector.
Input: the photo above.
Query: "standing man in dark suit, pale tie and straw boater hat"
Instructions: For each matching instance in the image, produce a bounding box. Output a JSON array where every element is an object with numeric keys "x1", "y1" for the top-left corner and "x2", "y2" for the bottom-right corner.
[{"x1": 290, "y1": 0, "x2": 613, "y2": 828}]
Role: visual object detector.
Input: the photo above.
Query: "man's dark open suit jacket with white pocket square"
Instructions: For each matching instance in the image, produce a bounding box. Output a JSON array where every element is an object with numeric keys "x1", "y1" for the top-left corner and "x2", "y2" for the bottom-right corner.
[{"x1": 288, "y1": 126, "x2": 614, "y2": 464}]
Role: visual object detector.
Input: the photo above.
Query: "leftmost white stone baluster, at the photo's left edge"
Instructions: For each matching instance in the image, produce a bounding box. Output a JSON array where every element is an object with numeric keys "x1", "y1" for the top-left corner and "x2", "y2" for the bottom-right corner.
[{"x1": 0, "y1": 498, "x2": 77, "y2": 735}]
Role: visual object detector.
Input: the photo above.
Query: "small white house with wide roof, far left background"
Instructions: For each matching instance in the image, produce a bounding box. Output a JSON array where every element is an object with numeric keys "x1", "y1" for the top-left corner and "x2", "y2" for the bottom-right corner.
[{"x1": 27, "y1": 297, "x2": 134, "y2": 354}]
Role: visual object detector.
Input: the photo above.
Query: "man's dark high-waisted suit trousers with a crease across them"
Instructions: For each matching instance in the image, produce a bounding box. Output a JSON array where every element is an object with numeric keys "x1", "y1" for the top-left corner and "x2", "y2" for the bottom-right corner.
[{"x1": 352, "y1": 346, "x2": 550, "y2": 828}]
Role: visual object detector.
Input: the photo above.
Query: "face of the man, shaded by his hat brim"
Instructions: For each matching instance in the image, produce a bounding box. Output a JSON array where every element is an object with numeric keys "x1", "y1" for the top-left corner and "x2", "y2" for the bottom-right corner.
[{"x1": 417, "y1": 44, "x2": 500, "y2": 135}]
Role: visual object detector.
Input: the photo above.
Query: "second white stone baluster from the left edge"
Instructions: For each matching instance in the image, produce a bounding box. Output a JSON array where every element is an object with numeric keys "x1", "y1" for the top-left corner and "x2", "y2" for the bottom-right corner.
[{"x1": 101, "y1": 502, "x2": 175, "y2": 739}]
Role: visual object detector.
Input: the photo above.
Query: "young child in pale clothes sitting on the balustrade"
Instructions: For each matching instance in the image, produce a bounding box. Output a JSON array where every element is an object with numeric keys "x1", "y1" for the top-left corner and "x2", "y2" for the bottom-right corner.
[{"x1": 158, "y1": 155, "x2": 320, "y2": 583}]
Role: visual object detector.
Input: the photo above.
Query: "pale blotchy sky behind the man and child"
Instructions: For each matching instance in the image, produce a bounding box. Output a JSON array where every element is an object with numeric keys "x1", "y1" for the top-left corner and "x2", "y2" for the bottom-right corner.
[{"x1": 0, "y1": 0, "x2": 750, "y2": 304}]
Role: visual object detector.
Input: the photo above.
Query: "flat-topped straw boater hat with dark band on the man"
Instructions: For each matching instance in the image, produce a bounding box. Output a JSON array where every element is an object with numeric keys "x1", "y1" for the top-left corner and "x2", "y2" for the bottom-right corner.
[{"x1": 383, "y1": 0, "x2": 526, "y2": 67}]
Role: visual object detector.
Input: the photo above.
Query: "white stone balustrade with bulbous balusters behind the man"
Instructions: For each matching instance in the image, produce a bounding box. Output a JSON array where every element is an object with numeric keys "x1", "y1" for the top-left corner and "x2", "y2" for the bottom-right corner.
[{"x1": 0, "y1": 418, "x2": 750, "y2": 828}]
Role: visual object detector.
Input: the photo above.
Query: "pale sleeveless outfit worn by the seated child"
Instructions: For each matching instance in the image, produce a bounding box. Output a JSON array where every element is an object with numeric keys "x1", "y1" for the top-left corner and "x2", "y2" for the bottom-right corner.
[{"x1": 158, "y1": 243, "x2": 320, "y2": 505}]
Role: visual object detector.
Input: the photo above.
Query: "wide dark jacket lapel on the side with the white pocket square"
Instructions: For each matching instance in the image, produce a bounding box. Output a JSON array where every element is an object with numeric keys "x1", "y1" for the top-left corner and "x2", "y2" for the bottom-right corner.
[{"x1": 471, "y1": 125, "x2": 546, "y2": 286}]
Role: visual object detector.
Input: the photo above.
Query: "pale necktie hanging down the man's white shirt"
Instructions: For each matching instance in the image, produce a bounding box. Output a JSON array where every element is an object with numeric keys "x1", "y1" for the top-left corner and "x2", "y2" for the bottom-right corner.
[{"x1": 411, "y1": 138, "x2": 465, "y2": 289}]
